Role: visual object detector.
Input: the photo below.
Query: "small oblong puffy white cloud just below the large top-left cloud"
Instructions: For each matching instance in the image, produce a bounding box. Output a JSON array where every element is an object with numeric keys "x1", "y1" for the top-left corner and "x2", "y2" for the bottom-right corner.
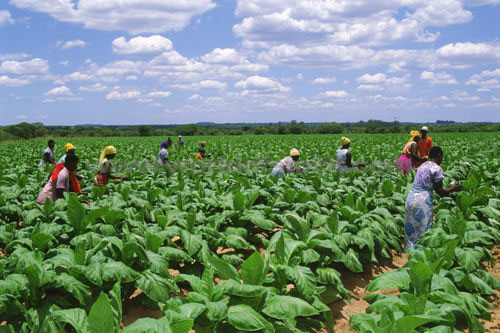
[{"x1": 112, "y1": 35, "x2": 172, "y2": 55}]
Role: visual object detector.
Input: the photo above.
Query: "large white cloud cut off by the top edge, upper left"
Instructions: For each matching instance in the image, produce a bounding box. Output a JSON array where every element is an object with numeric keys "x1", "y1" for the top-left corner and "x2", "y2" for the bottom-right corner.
[{"x1": 10, "y1": 0, "x2": 216, "y2": 34}]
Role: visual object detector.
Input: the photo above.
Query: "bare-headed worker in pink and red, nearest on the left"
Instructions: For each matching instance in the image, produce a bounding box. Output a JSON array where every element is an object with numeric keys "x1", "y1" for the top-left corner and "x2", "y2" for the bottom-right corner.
[{"x1": 36, "y1": 154, "x2": 83, "y2": 205}]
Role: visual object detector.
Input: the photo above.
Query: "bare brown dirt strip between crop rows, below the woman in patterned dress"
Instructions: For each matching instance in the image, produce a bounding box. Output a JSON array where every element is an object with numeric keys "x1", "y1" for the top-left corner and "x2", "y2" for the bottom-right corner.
[{"x1": 330, "y1": 251, "x2": 408, "y2": 333}]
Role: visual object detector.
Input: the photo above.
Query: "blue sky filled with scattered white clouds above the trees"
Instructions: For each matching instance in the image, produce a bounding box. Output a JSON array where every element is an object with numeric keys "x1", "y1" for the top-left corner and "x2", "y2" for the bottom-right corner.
[{"x1": 0, "y1": 0, "x2": 500, "y2": 125}]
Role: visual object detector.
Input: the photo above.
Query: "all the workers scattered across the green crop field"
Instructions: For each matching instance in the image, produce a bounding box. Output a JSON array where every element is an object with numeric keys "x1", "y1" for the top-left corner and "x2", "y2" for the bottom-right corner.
[{"x1": 37, "y1": 126, "x2": 462, "y2": 251}]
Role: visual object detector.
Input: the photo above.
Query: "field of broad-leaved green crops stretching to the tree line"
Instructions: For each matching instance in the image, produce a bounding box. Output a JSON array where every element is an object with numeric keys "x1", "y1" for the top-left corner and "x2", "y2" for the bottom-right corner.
[{"x1": 0, "y1": 133, "x2": 500, "y2": 333}]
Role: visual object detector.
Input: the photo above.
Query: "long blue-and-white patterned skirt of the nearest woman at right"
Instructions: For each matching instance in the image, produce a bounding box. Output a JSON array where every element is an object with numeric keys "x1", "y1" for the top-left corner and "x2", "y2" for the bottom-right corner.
[{"x1": 405, "y1": 187, "x2": 434, "y2": 251}]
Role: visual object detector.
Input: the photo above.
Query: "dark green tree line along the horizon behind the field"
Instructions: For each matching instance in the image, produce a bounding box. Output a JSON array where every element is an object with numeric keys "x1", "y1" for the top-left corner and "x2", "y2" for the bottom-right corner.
[{"x1": 0, "y1": 120, "x2": 500, "y2": 141}]
